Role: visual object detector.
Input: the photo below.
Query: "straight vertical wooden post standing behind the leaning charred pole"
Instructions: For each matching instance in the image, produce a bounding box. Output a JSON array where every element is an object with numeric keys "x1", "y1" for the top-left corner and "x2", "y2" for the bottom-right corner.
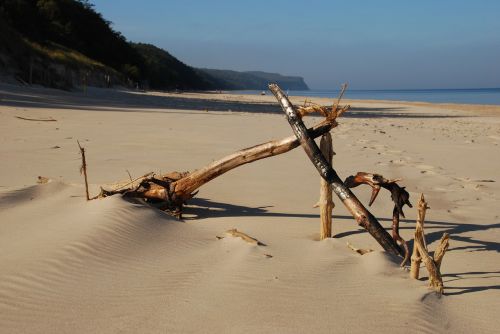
[{"x1": 319, "y1": 132, "x2": 334, "y2": 240}]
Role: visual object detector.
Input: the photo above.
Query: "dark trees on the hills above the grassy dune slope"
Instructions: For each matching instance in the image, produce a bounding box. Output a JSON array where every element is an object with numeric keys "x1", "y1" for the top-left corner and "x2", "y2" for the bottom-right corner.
[{"x1": 0, "y1": 0, "x2": 213, "y2": 89}]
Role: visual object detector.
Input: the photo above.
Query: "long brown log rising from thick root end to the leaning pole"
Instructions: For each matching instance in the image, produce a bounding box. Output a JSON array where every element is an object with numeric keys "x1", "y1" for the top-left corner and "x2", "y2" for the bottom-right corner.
[{"x1": 97, "y1": 106, "x2": 337, "y2": 218}]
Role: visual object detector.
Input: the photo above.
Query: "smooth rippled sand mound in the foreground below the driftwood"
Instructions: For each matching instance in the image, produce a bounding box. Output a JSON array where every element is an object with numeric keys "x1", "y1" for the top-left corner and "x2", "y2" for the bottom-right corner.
[{"x1": 0, "y1": 183, "x2": 484, "y2": 333}]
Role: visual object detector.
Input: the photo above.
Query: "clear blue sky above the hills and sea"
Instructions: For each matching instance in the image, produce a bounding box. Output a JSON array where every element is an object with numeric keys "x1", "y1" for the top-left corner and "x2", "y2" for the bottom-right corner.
[{"x1": 90, "y1": 0, "x2": 500, "y2": 89}]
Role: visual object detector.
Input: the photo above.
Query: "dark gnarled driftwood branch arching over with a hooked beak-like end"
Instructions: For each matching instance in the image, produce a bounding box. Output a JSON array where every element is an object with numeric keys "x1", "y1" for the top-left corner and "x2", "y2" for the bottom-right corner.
[{"x1": 345, "y1": 172, "x2": 412, "y2": 266}]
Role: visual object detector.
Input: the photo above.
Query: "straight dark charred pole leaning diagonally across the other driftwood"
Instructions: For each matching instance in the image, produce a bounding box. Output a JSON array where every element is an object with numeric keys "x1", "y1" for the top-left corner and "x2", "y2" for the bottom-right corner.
[{"x1": 269, "y1": 84, "x2": 404, "y2": 256}]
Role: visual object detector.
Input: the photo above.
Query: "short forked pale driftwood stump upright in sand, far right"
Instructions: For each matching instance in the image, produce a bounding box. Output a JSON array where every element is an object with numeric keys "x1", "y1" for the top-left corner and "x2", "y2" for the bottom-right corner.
[{"x1": 410, "y1": 194, "x2": 449, "y2": 294}]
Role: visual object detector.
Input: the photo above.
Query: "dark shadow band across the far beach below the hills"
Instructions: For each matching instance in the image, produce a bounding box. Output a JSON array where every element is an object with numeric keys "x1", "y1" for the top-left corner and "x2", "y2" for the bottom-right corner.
[{"x1": 0, "y1": 85, "x2": 463, "y2": 118}]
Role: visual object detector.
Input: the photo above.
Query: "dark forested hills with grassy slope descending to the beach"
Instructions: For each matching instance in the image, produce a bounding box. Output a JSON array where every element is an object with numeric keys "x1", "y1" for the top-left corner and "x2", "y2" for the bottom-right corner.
[{"x1": 0, "y1": 0, "x2": 303, "y2": 90}]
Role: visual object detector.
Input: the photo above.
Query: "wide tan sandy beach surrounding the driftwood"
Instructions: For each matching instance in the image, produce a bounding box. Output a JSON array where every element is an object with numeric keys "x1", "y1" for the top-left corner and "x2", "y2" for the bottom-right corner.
[{"x1": 0, "y1": 84, "x2": 500, "y2": 333}]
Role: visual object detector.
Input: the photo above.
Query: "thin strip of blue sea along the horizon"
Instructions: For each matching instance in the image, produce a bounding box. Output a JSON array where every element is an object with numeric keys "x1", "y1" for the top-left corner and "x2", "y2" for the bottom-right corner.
[{"x1": 234, "y1": 88, "x2": 500, "y2": 105}]
